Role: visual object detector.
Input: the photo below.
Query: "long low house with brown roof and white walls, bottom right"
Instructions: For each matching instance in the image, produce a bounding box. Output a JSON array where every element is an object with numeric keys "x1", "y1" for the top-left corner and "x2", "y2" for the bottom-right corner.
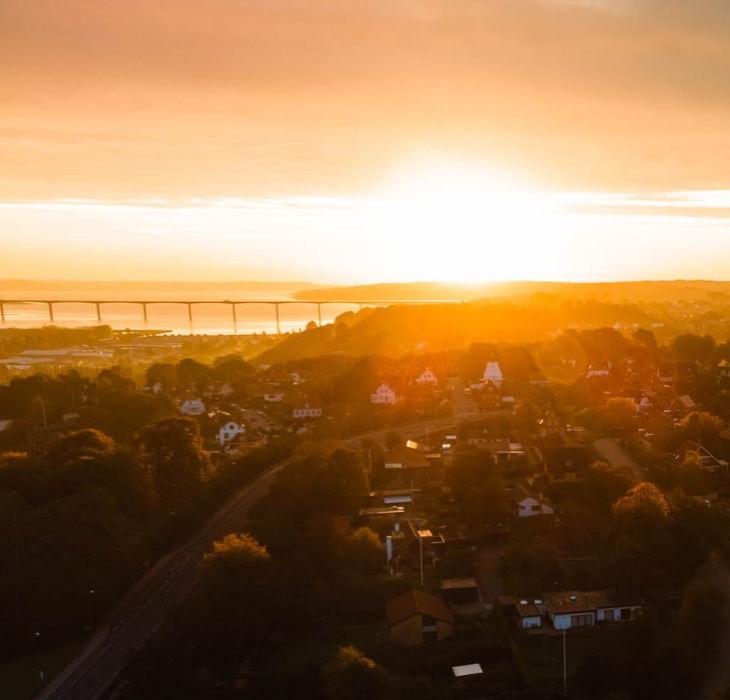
[{"x1": 543, "y1": 591, "x2": 644, "y2": 630}]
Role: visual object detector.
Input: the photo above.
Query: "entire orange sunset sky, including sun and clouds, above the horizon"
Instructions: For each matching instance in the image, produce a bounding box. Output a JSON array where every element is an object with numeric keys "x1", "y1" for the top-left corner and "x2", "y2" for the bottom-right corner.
[{"x1": 0, "y1": 0, "x2": 730, "y2": 283}]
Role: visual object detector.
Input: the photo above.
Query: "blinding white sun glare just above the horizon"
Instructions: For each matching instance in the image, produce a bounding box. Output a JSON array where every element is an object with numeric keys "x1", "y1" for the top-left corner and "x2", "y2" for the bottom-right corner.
[{"x1": 364, "y1": 159, "x2": 559, "y2": 282}]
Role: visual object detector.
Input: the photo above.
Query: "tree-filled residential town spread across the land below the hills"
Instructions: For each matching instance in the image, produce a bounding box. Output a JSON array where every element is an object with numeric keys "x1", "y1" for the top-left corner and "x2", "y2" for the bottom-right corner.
[{"x1": 0, "y1": 308, "x2": 730, "y2": 698}]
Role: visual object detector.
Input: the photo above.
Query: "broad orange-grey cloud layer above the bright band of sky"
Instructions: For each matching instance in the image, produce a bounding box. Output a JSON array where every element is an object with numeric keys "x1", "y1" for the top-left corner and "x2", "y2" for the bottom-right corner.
[{"x1": 0, "y1": 0, "x2": 730, "y2": 198}]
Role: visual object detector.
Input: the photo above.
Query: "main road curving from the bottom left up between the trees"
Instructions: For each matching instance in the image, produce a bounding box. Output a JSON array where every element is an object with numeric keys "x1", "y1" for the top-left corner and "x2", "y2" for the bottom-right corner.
[{"x1": 36, "y1": 418, "x2": 454, "y2": 700}]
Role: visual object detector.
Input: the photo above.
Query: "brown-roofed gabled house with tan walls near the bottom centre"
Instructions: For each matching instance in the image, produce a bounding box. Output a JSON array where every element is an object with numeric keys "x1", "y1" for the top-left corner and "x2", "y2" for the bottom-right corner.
[{"x1": 385, "y1": 590, "x2": 454, "y2": 647}]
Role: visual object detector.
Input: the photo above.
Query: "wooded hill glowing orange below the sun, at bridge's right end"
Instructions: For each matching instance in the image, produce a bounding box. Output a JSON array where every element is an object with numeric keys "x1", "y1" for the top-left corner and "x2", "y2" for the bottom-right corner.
[{"x1": 260, "y1": 281, "x2": 730, "y2": 362}]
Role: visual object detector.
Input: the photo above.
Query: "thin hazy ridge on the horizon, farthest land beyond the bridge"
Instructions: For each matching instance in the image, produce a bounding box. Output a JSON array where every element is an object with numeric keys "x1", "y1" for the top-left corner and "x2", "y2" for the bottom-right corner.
[{"x1": 294, "y1": 280, "x2": 730, "y2": 302}]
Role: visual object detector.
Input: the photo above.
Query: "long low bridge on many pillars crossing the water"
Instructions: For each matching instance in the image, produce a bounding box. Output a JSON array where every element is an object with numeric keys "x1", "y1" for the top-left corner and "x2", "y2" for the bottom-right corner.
[{"x1": 0, "y1": 298, "x2": 464, "y2": 334}]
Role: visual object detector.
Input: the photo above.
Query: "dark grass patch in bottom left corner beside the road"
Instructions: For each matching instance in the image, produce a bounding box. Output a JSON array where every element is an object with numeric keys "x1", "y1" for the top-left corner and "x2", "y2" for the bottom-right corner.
[{"x1": 0, "y1": 639, "x2": 86, "y2": 700}]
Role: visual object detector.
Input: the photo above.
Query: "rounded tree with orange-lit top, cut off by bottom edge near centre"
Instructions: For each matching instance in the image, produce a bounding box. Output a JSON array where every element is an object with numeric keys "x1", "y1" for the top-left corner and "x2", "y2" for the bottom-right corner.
[{"x1": 323, "y1": 646, "x2": 388, "y2": 700}]
